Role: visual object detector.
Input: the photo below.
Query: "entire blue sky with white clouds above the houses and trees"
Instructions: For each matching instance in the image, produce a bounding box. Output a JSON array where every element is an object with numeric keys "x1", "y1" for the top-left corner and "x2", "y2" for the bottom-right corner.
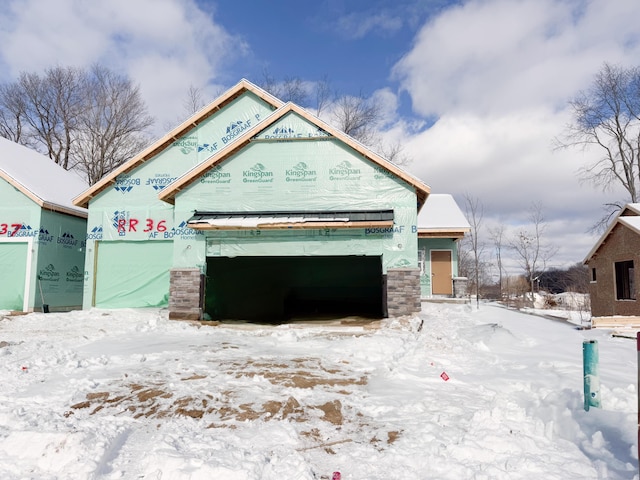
[{"x1": 0, "y1": 0, "x2": 640, "y2": 271}]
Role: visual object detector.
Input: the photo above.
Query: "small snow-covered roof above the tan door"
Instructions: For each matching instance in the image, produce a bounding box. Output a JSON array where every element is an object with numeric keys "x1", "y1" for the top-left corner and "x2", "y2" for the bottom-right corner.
[{"x1": 418, "y1": 193, "x2": 471, "y2": 238}]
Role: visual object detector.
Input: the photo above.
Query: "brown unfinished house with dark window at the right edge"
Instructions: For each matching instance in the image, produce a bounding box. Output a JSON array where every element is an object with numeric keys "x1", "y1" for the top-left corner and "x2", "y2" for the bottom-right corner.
[{"x1": 584, "y1": 203, "x2": 640, "y2": 327}]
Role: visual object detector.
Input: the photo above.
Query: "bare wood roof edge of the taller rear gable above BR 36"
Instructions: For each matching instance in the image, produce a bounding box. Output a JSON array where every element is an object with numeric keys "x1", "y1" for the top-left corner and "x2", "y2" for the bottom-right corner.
[{"x1": 73, "y1": 79, "x2": 282, "y2": 207}]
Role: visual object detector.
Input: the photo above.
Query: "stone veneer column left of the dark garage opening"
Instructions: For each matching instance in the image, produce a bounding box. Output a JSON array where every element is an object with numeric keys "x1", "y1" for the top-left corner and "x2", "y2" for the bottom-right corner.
[{"x1": 169, "y1": 268, "x2": 202, "y2": 320}]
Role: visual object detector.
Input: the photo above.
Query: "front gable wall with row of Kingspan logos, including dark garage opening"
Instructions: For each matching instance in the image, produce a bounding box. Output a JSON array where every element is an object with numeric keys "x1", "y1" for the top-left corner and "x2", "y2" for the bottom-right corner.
[{"x1": 160, "y1": 105, "x2": 423, "y2": 320}]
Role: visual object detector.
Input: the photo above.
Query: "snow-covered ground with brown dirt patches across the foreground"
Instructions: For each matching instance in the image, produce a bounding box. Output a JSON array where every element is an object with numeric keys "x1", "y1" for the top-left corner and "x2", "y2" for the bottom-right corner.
[{"x1": 0, "y1": 304, "x2": 638, "y2": 480}]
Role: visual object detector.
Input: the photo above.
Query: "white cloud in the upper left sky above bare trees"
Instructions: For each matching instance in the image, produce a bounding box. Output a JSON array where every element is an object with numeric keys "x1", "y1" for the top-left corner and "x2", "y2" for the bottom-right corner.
[{"x1": 0, "y1": 0, "x2": 247, "y2": 133}]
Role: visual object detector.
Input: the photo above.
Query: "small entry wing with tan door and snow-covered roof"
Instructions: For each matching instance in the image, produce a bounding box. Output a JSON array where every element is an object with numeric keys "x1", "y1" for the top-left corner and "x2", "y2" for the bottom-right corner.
[{"x1": 418, "y1": 193, "x2": 471, "y2": 298}]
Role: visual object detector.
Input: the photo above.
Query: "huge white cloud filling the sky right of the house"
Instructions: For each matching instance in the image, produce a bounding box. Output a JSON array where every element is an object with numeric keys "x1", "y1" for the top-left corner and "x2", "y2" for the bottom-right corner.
[{"x1": 392, "y1": 0, "x2": 640, "y2": 265}]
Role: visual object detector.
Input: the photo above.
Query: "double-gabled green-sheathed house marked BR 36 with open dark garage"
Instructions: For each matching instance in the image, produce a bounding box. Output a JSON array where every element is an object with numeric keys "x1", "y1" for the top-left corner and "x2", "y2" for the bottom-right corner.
[{"x1": 74, "y1": 80, "x2": 470, "y2": 320}]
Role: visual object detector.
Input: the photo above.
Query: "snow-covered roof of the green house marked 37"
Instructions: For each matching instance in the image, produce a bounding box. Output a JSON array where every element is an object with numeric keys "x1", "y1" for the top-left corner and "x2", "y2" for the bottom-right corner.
[{"x1": 0, "y1": 137, "x2": 87, "y2": 218}]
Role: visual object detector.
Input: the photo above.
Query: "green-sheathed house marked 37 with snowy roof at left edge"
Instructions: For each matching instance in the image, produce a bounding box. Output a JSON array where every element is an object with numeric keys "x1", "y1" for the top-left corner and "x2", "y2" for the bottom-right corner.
[{"x1": 0, "y1": 137, "x2": 87, "y2": 312}]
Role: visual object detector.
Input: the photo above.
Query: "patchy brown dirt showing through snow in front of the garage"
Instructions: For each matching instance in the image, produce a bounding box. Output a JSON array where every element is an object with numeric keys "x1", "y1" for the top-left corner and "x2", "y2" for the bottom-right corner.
[{"x1": 69, "y1": 354, "x2": 401, "y2": 454}]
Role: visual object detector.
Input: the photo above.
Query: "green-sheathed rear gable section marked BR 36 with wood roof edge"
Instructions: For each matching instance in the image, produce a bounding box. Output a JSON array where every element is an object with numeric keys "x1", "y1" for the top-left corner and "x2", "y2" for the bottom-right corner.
[{"x1": 75, "y1": 81, "x2": 281, "y2": 308}]
